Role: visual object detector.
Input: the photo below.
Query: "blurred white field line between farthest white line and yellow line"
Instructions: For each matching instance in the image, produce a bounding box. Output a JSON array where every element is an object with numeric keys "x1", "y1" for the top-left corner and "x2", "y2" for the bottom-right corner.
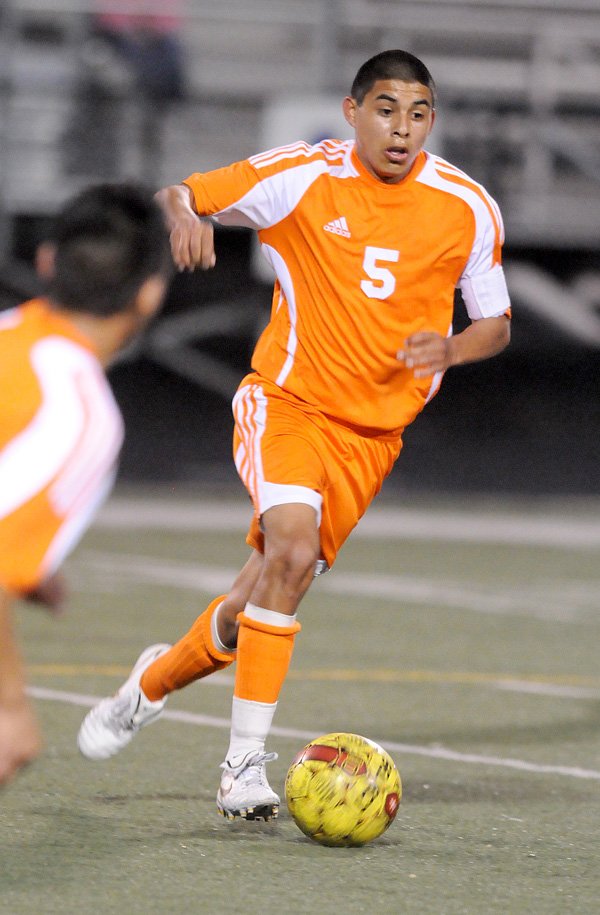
[{"x1": 73, "y1": 550, "x2": 598, "y2": 623}]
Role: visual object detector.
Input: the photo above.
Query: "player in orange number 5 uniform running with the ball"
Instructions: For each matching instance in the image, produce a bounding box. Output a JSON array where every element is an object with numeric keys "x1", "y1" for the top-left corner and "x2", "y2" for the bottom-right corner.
[{"x1": 79, "y1": 50, "x2": 510, "y2": 819}]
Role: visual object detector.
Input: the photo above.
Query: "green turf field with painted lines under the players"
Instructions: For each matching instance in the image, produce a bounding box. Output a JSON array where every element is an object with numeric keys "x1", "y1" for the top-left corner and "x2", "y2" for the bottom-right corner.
[{"x1": 0, "y1": 492, "x2": 600, "y2": 915}]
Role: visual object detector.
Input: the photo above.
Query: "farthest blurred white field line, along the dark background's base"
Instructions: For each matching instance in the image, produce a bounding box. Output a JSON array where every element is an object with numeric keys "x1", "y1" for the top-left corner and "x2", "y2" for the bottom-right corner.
[{"x1": 95, "y1": 496, "x2": 600, "y2": 550}]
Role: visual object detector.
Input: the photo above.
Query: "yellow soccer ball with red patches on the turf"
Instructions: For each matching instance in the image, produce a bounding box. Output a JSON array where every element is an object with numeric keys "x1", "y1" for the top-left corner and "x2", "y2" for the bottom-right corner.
[{"x1": 285, "y1": 734, "x2": 402, "y2": 846}]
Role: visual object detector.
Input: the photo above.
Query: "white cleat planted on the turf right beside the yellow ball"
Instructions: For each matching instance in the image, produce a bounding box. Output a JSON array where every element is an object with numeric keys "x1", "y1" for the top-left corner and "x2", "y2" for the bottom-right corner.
[{"x1": 217, "y1": 750, "x2": 280, "y2": 821}]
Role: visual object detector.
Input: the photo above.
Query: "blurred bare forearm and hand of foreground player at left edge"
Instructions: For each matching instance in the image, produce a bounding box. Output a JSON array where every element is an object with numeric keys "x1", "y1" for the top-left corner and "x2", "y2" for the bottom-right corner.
[{"x1": 0, "y1": 585, "x2": 41, "y2": 785}]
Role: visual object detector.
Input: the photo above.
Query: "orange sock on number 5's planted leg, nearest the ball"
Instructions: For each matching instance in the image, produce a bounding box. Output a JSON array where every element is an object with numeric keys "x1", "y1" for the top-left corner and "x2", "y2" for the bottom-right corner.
[{"x1": 234, "y1": 613, "x2": 301, "y2": 704}]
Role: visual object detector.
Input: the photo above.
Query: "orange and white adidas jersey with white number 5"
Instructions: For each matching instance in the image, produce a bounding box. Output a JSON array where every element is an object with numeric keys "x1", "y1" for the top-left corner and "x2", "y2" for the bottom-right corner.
[{"x1": 185, "y1": 140, "x2": 510, "y2": 433}]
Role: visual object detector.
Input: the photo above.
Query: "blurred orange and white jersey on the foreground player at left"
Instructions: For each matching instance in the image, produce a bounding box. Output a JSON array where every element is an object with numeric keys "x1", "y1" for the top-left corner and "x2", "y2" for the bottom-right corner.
[{"x1": 0, "y1": 299, "x2": 123, "y2": 593}]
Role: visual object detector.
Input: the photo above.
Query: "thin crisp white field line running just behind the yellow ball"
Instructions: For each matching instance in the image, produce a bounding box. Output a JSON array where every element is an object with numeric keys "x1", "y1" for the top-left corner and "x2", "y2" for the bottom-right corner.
[{"x1": 28, "y1": 686, "x2": 600, "y2": 781}]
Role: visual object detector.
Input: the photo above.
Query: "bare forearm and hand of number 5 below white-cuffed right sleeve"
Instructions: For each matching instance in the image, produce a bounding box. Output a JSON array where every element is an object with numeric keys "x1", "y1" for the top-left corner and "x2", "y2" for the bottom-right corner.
[{"x1": 398, "y1": 315, "x2": 510, "y2": 378}]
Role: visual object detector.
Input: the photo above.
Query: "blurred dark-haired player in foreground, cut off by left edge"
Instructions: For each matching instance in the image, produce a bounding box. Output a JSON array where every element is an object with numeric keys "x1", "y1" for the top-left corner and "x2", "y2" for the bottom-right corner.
[{"x1": 0, "y1": 185, "x2": 173, "y2": 784}]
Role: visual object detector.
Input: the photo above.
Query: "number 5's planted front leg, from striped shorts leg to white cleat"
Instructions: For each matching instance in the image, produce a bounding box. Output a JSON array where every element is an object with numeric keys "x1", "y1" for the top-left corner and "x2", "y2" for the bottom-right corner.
[{"x1": 217, "y1": 376, "x2": 327, "y2": 819}]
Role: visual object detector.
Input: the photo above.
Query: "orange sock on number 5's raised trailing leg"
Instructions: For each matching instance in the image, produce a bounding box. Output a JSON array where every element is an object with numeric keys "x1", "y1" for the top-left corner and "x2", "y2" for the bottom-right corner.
[{"x1": 140, "y1": 594, "x2": 236, "y2": 702}]
